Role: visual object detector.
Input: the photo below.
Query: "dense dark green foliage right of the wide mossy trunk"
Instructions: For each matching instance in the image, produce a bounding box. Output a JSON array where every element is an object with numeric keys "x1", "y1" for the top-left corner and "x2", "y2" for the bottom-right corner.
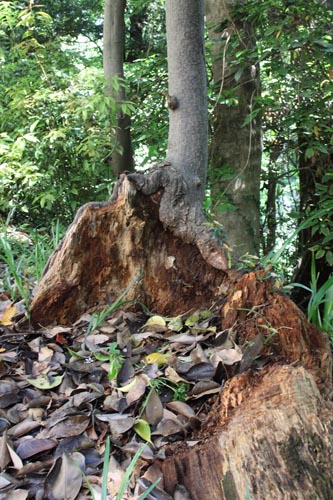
[{"x1": 218, "y1": 0, "x2": 333, "y2": 272}]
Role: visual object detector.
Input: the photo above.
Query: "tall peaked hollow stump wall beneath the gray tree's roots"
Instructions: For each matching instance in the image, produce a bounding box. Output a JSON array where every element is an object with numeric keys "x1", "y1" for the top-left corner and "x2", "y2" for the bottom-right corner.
[{"x1": 31, "y1": 175, "x2": 227, "y2": 325}]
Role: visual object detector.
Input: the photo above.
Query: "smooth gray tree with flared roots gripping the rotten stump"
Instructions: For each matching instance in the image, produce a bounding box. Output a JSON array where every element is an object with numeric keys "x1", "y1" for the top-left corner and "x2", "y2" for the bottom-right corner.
[{"x1": 128, "y1": 0, "x2": 228, "y2": 269}]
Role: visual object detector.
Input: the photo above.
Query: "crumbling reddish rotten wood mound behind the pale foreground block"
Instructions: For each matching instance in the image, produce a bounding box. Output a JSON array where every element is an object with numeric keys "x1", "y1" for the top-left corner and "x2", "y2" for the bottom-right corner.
[{"x1": 221, "y1": 270, "x2": 332, "y2": 390}]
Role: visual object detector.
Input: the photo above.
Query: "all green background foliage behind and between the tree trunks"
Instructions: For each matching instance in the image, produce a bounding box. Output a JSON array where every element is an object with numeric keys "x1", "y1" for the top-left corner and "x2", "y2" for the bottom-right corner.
[{"x1": 0, "y1": 0, "x2": 333, "y2": 290}]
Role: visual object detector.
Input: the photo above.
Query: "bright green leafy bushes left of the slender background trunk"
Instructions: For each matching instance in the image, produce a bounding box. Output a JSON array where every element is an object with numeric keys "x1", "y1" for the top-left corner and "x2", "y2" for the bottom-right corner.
[{"x1": 0, "y1": 2, "x2": 118, "y2": 225}]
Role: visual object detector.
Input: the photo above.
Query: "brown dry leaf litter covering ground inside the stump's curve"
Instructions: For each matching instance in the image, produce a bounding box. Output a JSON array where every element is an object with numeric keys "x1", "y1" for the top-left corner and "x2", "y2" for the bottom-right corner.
[{"x1": 0, "y1": 294, "x2": 268, "y2": 500}]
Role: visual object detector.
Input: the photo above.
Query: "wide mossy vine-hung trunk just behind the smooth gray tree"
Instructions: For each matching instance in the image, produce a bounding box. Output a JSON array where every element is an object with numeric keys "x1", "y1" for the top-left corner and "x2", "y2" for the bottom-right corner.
[{"x1": 206, "y1": 0, "x2": 261, "y2": 255}]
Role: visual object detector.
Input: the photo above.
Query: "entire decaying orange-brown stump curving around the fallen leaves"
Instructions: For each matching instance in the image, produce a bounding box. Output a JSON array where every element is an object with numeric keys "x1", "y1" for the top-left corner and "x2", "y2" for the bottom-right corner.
[{"x1": 31, "y1": 176, "x2": 333, "y2": 500}]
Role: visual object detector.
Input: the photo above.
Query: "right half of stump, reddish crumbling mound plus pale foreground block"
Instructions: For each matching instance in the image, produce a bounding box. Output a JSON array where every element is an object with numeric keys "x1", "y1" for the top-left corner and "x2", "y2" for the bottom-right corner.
[{"x1": 162, "y1": 272, "x2": 333, "y2": 500}]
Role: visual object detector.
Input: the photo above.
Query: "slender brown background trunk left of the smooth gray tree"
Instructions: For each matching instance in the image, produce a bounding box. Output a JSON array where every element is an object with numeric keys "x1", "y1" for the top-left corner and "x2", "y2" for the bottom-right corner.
[{"x1": 103, "y1": 0, "x2": 134, "y2": 175}]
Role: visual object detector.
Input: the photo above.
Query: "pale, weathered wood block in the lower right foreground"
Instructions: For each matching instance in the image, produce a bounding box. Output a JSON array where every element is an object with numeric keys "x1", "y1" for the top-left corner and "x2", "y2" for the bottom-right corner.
[{"x1": 162, "y1": 365, "x2": 333, "y2": 500}]
